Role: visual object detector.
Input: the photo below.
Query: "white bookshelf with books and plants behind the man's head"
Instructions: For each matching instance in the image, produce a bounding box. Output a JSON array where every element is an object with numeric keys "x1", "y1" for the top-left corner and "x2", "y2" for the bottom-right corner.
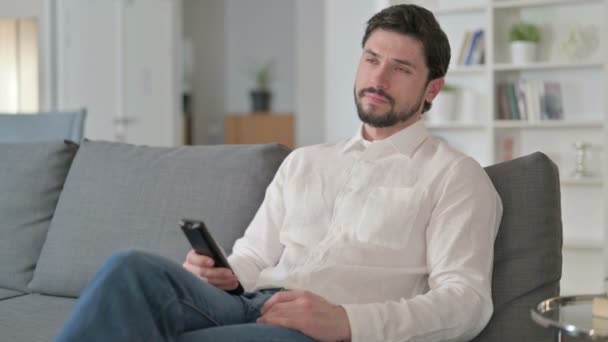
[{"x1": 378, "y1": 0, "x2": 608, "y2": 292}]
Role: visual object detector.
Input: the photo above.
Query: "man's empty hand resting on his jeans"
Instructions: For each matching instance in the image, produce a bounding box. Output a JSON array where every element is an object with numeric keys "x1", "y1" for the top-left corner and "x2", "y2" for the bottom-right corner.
[{"x1": 257, "y1": 291, "x2": 350, "y2": 342}]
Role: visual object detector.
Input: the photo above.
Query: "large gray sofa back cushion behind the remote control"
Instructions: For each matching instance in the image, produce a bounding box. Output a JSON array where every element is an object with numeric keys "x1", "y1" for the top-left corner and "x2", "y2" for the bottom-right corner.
[{"x1": 30, "y1": 142, "x2": 288, "y2": 296}]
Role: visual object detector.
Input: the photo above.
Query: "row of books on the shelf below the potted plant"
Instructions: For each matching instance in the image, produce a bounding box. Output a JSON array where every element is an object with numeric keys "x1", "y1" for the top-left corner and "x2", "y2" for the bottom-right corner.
[{"x1": 496, "y1": 80, "x2": 564, "y2": 123}]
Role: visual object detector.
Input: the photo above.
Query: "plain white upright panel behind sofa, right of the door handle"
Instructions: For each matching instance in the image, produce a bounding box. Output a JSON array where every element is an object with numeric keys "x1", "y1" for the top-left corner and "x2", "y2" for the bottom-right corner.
[{"x1": 122, "y1": 0, "x2": 183, "y2": 146}]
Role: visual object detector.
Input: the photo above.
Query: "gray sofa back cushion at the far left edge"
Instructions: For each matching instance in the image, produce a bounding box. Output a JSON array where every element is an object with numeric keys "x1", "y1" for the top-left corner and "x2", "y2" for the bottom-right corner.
[{"x1": 0, "y1": 141, "x2": 77, "y2": 291}]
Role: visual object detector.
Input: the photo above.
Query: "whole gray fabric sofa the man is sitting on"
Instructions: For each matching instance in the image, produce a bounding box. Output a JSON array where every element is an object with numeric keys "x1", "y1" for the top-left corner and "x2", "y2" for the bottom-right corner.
[{"x1": 0, "y1": 141, "x2": 562, "y2": 342}]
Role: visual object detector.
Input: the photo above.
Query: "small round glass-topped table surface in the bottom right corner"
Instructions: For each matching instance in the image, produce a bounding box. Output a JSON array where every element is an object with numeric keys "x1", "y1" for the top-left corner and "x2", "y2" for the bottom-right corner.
[{"x1": 532, "y1": 294, "x2": 608, "y2": 341}]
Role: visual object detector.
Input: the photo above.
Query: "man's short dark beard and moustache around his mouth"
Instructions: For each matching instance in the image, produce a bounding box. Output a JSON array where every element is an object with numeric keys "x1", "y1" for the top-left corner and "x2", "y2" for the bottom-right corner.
[{"x1": 354, "y1": 87, "x2": 424, "y2": 128}]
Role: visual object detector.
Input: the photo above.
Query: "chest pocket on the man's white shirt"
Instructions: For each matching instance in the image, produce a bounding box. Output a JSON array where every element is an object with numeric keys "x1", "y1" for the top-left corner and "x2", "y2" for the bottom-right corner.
[{"x1": 354, "y1": 187, "x2": 429, "y2": 249}]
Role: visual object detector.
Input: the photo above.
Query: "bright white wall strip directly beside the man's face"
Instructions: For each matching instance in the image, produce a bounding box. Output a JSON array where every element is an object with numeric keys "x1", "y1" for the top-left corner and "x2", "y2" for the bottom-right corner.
[{"x1": 325, "y1": 0, "x2": 378, "y2": 141}]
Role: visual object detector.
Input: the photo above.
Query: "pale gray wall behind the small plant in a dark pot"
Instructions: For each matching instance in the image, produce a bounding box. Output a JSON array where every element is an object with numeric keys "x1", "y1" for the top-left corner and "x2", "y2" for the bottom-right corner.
[{"x1": 224, "y1": 0, "x2": 295, "y2": 113}]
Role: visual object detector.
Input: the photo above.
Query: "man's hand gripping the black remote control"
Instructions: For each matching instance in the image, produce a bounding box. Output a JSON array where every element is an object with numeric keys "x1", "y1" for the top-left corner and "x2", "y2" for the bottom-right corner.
[{"x1": 182, "y1": 250, "x2": 239, "y2": 290}]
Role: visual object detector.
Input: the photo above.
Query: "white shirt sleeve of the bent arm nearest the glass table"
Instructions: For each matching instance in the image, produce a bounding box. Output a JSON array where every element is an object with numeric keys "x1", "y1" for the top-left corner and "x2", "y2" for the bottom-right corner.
[{"x1": 343, "y1": 158, "x2": 502, "y2": 342}]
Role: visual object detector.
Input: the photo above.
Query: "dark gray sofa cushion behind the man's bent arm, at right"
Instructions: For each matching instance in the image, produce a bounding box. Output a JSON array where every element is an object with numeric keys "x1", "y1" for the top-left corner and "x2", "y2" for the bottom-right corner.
[{"x1": 474, "y1": 152, "x2": 562, "y2": 342}]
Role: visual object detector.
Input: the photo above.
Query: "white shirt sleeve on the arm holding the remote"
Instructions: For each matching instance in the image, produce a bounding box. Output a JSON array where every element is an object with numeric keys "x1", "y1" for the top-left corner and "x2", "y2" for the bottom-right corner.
[{"x1": 228, "y1": 152, "x2": 293, "y2": 291}]
